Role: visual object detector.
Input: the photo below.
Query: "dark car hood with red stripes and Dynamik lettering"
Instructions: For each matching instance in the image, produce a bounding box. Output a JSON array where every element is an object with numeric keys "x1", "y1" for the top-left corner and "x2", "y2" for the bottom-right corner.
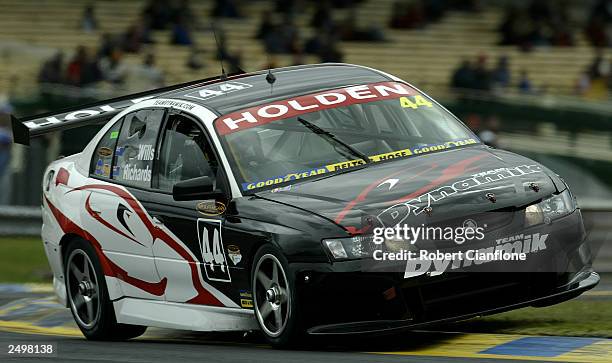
[{"x1": 257, "y1": 146, "x2": 562, "y2": 234}]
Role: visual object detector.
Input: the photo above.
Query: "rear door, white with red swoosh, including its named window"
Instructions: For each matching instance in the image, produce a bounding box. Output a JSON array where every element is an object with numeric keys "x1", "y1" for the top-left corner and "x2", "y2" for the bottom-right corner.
[{"x1": 83, "y1": 109, "x2": 166, "y2": 300}]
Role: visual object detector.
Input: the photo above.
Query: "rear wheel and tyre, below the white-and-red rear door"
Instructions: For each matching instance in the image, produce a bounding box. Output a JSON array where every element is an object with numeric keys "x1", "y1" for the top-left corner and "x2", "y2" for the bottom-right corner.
[{"x1": 64, "y1": 238, "x2": 147, "y2": 340}]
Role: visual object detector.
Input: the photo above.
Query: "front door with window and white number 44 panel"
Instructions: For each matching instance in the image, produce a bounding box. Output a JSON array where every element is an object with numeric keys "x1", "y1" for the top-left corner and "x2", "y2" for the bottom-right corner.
[{"x1": 136, "y1": 111, "x2": 240, "y2": 307}]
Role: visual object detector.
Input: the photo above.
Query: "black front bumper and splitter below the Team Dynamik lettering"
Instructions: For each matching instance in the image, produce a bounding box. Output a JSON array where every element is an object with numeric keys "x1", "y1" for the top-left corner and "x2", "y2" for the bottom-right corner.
[{"x1": 290, "y1": 210, "x2": 599, "y2": 335}]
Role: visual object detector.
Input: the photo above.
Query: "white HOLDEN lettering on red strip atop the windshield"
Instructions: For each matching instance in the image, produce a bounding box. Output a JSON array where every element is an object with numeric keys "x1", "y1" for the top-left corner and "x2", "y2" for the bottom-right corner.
[{"x1": 215, "y1": 82, "x2": 416, "y2": 135}]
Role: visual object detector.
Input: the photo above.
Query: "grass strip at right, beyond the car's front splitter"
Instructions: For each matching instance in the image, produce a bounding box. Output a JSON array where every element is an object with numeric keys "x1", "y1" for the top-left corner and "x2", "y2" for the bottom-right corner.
[{"x1": 446, "y1": 297, "x2": 612, "y2": 338}]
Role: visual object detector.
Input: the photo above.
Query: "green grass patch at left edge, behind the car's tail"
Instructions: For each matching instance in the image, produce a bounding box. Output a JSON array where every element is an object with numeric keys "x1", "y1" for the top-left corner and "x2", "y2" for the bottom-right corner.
[{"x1": 0, "y1": 237, "x2": 51, "y2": 283}]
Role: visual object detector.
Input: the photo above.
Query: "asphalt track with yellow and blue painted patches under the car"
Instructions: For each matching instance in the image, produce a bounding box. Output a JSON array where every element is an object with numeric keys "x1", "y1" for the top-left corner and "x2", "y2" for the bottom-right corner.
[{"x1": 0, "y1": 281, "x2": 612, "y2": 363}]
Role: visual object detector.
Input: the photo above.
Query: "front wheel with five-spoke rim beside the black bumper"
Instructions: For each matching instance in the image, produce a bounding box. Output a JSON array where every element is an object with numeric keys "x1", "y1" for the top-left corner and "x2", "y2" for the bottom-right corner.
[{"x1": 251, "y1": 244, "x2": 305, "y2": 348}]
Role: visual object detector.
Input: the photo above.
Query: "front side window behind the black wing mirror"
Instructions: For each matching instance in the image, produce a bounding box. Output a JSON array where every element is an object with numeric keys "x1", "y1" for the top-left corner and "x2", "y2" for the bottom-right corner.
[{"x1": 157, "y1": 114, "x2": 219, "y2": 192}]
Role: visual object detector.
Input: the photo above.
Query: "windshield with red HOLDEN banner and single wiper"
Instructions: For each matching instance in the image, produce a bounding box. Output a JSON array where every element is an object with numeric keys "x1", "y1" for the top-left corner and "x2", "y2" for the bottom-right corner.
[{"x1": 215, "y1": 82, "x2": 479, "y2": 194}]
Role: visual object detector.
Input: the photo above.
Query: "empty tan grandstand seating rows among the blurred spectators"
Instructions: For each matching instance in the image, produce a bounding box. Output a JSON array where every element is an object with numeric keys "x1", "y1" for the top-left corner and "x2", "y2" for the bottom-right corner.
[{"x1": 0, "y1": 0, "x2": 612, "y2": 99}]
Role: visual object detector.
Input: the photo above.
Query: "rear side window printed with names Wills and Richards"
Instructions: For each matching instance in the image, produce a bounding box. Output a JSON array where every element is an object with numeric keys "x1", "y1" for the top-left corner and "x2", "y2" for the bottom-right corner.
[{"x1": 112, "y1": 110, "x2": 164, "y2": 188}]
